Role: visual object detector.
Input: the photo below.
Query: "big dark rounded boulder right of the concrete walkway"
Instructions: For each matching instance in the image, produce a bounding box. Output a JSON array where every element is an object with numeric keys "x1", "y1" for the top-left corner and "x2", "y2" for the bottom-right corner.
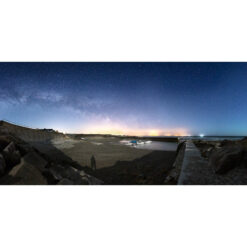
[{"x1": 209, "y1": 145, "x2": 243, "y2": 174}]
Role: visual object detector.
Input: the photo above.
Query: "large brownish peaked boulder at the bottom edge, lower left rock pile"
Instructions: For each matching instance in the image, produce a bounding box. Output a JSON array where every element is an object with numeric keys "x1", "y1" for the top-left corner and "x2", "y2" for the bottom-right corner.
[{"x1": 9, "y1": 159, "x2": 47, "y2": 185}]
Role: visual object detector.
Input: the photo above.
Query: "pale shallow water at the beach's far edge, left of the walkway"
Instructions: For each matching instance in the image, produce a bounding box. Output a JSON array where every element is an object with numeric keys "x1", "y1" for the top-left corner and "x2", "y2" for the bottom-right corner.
[{"x1": 120, "y1": 141, "x2": 177, "y2": 151}]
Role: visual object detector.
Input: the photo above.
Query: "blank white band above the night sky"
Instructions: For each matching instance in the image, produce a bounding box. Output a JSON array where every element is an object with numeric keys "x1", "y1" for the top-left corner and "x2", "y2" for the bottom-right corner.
[{"x1": 0, "y1": 0, "x2": 247, "y2": 61}]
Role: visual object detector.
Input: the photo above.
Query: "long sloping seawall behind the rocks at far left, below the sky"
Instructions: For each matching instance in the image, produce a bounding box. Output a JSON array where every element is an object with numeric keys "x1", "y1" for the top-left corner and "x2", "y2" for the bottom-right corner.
[{"x1": 0, "y1": 121, "x2": 65, "y2": 142}]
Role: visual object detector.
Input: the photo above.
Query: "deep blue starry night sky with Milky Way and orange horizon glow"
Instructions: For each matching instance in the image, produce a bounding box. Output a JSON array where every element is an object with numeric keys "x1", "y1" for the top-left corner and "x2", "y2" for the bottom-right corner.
[{"x1": 0, "y1": 62, "x2": 247, "y2": 136}]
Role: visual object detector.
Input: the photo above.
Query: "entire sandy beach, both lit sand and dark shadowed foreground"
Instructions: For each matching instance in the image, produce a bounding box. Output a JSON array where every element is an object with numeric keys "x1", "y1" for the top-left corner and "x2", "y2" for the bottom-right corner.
[{"x1": 28, "y1": 136, "x2": 176, "y2": 185}]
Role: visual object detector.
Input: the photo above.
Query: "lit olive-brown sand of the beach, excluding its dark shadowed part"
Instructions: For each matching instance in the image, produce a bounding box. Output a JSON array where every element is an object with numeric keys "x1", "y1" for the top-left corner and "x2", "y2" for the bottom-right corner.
[{"x1": 32, "y1": 137, "x2": 156, "y2": 169}]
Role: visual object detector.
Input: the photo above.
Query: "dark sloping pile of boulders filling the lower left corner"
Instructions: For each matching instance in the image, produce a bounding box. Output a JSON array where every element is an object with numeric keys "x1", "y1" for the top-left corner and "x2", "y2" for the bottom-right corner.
[{"x1": 0, "y1": 131, "x2": 103, "y2": 185}]
